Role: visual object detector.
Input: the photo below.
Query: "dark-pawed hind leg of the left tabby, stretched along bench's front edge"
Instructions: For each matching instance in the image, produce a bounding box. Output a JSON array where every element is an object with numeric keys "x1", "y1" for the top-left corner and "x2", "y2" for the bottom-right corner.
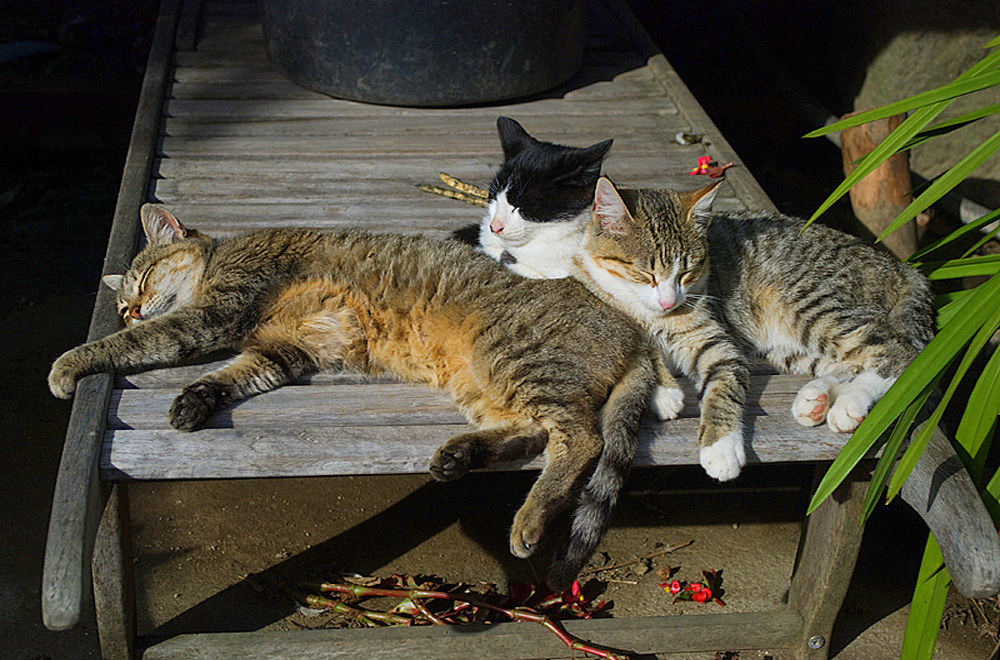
[{"x1": 430, "y1": 422, "x2": 549, "y2": 481}]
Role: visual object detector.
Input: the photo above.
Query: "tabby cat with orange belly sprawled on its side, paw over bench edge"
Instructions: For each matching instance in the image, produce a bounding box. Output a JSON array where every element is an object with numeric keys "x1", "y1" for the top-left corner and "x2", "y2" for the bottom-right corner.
[{"x1": 49, "y1": 204, "x2": 661, "y2": 589}]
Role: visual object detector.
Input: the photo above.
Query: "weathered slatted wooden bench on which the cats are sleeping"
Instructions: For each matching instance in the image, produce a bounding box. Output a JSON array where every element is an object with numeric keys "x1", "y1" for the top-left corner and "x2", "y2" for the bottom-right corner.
[{"x1": 42, "y1": 0, "x2": 996, "y2": 659}]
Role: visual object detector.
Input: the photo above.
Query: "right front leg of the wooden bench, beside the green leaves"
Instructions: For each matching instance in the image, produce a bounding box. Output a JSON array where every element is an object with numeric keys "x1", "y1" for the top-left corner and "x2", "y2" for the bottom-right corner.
[{"x1": 788, "y1": 466, "x2": 870, "y2": 660}]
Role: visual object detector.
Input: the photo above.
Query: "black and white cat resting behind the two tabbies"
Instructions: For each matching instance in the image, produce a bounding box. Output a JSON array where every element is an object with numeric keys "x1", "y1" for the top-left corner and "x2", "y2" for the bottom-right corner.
[{"x1": 479, "y1": 117, "x2": 611, "y2": 279}]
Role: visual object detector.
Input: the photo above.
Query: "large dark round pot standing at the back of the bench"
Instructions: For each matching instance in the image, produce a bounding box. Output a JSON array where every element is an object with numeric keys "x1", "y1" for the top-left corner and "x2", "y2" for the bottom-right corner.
[{"x1": 260, "y1": 0, "x2": 585, "y2": 106}]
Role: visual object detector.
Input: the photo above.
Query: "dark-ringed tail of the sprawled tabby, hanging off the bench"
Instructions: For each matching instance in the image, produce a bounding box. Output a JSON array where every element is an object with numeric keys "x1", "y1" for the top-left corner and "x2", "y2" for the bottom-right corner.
[{"x1": 547, "y1": 347, "x2": 656, "y2": 592}]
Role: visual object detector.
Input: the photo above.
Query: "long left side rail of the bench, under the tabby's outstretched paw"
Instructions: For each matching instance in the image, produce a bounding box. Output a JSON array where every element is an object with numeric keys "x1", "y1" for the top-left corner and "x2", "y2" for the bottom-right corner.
[{"x1": 42, "y1": 0, "x2": 186, "y2": 630}]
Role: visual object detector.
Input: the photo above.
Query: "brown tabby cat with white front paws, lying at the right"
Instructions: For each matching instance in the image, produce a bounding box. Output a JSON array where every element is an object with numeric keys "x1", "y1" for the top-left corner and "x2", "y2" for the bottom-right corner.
[{"x1": 575, "y1": 178, "x2": 934, "y2": 480}]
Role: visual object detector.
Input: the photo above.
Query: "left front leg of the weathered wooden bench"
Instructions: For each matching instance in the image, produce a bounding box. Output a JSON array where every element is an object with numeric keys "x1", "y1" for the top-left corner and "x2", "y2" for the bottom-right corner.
[{"x1": 91, "y1": 483, "x2": 136, "y2": 660}]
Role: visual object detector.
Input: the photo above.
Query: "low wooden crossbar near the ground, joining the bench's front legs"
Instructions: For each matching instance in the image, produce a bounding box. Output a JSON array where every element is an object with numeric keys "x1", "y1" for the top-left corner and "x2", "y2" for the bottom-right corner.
[{"x1": 142, "y1": 610, "x2": 802, "y2": 660}]
